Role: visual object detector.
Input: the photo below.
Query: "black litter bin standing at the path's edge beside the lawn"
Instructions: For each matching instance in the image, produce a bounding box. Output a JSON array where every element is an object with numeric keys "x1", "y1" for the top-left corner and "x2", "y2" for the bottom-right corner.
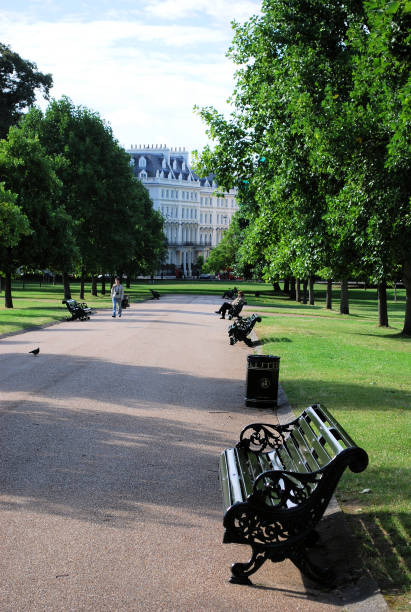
[{"x1": 245, "y1": 355, "x2": 280, "y2": 406}]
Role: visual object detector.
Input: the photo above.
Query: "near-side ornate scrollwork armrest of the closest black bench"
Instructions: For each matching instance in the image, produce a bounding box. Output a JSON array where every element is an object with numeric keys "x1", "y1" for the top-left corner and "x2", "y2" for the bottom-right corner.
[{"x1": 250, "y1": 470, "x2": 324, "y2": 508}]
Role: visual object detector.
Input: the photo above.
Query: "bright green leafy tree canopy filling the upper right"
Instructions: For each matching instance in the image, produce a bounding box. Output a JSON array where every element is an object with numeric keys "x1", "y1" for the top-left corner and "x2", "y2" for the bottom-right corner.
[{"x1": 197, "y1": 0, "x2": 411, "y2": 333}]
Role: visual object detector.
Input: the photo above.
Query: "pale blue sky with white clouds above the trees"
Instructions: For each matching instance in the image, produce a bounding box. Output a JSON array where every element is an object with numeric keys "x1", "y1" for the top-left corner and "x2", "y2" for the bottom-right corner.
[{"x1": 0, "y1": 0, "x2": 261, "y2": 150}]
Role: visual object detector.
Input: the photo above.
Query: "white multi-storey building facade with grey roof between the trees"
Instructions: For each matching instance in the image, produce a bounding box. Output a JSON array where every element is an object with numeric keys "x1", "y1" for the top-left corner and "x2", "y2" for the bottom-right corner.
[{"x1": 127, "y1": 145, "x2": 238, "y2": 276}]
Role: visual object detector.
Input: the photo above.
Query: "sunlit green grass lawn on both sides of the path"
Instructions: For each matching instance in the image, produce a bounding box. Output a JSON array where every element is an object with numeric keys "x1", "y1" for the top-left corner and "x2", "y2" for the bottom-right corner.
[{"x1": 0, "y1": 281, "x2": 411, "y2": 610}]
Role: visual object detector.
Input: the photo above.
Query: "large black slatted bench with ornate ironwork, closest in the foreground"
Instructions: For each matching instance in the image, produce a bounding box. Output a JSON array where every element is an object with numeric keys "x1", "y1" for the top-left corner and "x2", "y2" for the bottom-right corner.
[{"x1": 220, "y1": 404, "x2": 368, "y2": 584}]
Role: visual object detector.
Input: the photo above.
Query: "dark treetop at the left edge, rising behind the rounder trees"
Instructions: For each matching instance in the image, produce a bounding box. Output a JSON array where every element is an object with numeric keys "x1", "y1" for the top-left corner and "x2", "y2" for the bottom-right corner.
[{"x1": 0, "y1": 43, "x2": 53, "y2": 139}]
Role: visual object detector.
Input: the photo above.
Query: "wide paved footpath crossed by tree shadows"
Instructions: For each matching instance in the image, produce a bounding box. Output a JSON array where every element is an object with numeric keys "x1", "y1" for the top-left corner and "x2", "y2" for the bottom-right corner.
[{"x1": 0, "y1": 296, "x2": 386, "y2": 612}]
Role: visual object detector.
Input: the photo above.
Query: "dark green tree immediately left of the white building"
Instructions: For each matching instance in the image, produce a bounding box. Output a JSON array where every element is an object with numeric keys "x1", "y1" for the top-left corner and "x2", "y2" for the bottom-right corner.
[{"x1": 23, "y1": 97, "x2": 164, "y2": 298}]
